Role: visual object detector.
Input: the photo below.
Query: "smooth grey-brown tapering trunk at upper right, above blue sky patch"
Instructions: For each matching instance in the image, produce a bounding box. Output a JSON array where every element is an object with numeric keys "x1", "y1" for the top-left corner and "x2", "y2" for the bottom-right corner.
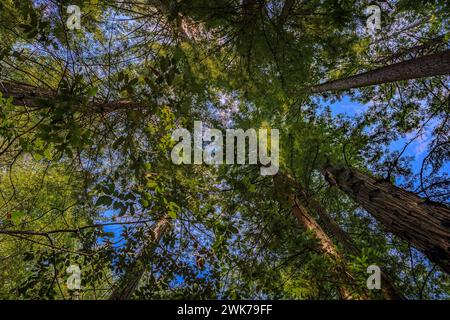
[{"x1": 311, "y1": 50, "x2": 450, "y2": 93}]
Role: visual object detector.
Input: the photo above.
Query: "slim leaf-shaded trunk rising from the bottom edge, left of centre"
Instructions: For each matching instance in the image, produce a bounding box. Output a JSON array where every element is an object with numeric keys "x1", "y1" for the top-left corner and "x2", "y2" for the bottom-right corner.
[{"x1": 109, "y1": 217, "x2": 170, "y2": 300}]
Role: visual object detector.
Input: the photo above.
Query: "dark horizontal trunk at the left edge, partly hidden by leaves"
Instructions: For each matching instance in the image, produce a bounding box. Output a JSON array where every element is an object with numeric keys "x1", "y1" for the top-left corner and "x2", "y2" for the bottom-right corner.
[{"x1": 0, "y1": 82, "x2": 147, "y2": 113}]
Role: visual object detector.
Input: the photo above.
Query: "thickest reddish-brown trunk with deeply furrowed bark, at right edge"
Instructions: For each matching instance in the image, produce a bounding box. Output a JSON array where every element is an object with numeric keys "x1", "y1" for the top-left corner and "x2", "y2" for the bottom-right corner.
[{"x1": 322, "y1": 163, "x2": 450, "y2": 273}]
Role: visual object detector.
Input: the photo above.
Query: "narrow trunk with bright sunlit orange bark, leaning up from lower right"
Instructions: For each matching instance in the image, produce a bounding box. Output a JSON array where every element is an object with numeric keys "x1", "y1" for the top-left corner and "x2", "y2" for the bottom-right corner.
[{"x1": 274, "y1": 175, "x2": 367, "y2": 300}]
